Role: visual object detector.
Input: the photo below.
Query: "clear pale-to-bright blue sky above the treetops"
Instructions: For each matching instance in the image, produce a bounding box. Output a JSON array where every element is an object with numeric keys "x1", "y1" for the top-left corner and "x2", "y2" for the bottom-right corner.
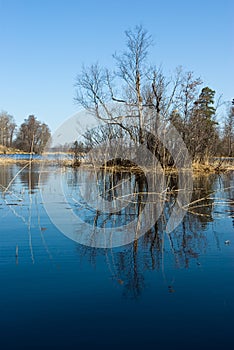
[{"x1": 0, "y1": 0, "x2": 234, "y2": 130}]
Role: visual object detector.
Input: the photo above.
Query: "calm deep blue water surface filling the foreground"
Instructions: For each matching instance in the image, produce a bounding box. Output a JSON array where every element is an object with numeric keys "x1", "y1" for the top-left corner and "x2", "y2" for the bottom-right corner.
[{"x1": 0, "y1": 165, "x2": 234, "y2": 349}]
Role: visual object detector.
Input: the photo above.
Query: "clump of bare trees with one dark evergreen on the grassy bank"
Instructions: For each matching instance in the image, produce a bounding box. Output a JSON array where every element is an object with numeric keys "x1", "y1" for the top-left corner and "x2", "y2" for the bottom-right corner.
[{"x1": 75, "y1": 26, "x2": 223, "y2": 165}]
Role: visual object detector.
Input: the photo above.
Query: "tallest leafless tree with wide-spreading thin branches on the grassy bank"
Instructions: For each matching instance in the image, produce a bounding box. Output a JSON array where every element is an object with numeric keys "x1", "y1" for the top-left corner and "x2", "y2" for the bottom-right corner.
[{"x1": 75, "y1": 26, "x2": 185, "y2": 166}]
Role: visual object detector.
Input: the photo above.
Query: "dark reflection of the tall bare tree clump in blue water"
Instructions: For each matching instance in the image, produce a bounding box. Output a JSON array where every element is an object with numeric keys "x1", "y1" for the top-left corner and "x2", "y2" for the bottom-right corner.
[{"x1": 69, "y1": 171, "x2": 225, "y2": 298}]
